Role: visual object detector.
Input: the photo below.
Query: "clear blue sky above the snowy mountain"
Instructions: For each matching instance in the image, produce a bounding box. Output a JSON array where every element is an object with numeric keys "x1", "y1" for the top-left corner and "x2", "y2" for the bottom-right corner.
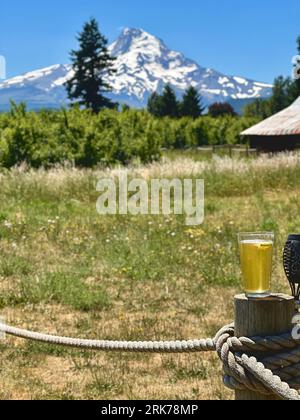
[{"x1": 0, "y1": 0, "x2": 300, "y2": 82}]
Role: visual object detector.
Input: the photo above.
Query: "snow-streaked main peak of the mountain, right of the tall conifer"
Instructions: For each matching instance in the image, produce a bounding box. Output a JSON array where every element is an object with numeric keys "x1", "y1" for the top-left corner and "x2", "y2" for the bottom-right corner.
[{"x1": 110, "y1": 29, "x2": 272, "y2": 104}]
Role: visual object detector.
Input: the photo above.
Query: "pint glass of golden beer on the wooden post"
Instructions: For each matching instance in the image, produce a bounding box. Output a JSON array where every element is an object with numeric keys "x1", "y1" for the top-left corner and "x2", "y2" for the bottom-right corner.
[{"x1": 238, "y1": 232, "x2": 274, "y2": 298}]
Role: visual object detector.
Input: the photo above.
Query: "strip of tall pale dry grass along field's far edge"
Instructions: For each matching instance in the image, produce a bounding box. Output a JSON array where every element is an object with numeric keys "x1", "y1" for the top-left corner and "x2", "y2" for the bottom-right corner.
[{"x1": 0, "y1": 152, "x2": 300, "y2": 185}]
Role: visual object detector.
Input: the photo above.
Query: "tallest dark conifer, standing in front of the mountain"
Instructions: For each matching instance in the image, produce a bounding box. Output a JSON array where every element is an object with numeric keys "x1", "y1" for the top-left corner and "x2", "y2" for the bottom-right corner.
[{"x1": 66, "y1": 18, "x2": 116, "y2": 112}]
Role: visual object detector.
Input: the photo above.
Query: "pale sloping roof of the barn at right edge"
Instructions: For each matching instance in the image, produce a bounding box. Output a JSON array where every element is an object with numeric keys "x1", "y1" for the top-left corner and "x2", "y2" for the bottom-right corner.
[{"x1": 241, "y1": 97, "x2": 300, "y2": 136}]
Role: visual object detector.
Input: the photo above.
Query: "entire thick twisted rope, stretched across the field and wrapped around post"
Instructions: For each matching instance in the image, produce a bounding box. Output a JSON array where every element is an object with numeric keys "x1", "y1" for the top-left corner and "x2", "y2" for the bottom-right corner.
[{"x1": 0, "y1": 322, "x2": 300, "y2": 401}]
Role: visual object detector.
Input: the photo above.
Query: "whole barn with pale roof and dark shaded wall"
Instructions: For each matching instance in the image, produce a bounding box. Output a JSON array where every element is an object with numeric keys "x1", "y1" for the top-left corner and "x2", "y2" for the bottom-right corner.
[{"x1": 241, "y1": 98, "x2": 300, "y2": 152}]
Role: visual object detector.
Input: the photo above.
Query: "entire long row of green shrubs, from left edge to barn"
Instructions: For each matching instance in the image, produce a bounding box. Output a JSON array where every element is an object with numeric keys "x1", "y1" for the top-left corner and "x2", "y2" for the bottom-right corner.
[{"x1": 0, "y1": 104, "x2": 256, "y2": 168}]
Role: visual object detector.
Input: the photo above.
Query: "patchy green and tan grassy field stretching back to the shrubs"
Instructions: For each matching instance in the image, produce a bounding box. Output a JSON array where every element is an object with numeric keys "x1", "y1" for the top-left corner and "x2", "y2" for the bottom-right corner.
[{"x1": 0, "y1": 155, "x2": 300, "y2": 399}]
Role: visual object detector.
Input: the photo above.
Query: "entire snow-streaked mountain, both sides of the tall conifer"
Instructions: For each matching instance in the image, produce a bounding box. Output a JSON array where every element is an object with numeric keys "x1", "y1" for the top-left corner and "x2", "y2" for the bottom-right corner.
[{"x1": 0, "y1": 28, "x2": 272, "y2": 109}]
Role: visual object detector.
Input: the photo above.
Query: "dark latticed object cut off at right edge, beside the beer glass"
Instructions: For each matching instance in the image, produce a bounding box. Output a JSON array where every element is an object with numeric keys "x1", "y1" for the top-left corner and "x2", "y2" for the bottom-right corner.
[{"x1": 283, "y1": 235, "x2": 300, "y2": 301}]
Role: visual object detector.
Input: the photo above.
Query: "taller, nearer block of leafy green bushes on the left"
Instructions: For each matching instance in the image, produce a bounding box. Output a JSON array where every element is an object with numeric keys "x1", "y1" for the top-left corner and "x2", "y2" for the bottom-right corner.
[{"x1": 0, "y1": 104, "x2": 161, "y2": 168}]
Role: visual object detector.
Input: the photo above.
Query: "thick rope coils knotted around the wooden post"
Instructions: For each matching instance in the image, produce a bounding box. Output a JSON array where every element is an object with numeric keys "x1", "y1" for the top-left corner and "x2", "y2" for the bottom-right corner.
[{"x1": 214, "y1": 324, "x2": 300, "y2": 400}]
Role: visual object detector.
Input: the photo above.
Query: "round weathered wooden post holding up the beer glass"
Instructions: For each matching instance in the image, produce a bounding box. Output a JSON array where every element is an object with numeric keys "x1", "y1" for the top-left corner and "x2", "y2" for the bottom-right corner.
[{"x1": 234, "y1": 294, "x2": 295, "y2": 401}]
